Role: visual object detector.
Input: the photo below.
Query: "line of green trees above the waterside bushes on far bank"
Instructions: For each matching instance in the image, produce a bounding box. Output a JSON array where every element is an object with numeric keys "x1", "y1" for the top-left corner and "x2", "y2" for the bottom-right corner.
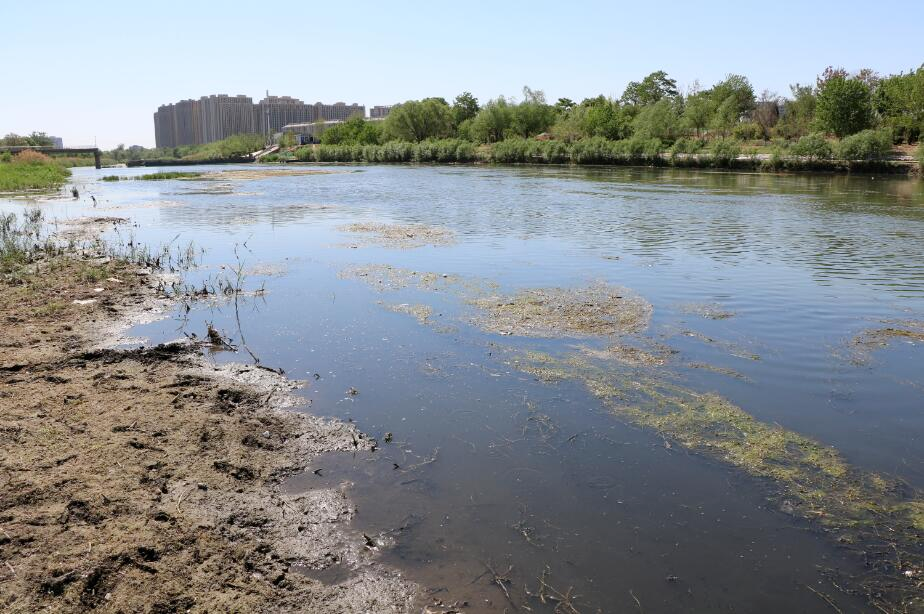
[{"x1": 321, "y1": 65, "x2": 924, "y2": 156}]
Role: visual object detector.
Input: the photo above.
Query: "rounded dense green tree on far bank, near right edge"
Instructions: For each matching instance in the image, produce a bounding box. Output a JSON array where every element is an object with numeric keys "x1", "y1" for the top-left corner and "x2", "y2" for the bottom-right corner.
[{"x1": 815, "y1": 74, "x2": 873, "y2": 138}]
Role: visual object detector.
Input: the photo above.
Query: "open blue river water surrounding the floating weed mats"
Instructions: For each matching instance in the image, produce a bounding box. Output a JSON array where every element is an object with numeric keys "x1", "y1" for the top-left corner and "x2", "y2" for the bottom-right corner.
[{"x1": 9, "y1": 165, "x2": 924, "y2": 613}]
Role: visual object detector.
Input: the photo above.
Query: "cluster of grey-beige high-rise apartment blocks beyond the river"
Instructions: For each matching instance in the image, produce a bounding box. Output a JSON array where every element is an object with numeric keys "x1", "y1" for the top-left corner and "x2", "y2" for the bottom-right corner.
[{"x1": 154, "y1": 92, "x2": 391, "y2": 147}]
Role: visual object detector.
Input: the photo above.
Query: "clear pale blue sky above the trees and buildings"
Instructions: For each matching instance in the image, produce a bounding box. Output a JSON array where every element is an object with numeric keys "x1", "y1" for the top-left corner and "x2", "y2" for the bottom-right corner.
[{"x1": 0, "y1": 0, "x2": 924, "y2": 148}]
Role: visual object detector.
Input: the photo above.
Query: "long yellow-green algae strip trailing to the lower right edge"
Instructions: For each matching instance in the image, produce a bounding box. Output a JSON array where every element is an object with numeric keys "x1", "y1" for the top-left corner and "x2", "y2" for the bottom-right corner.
[{"x1": 510, "y1": 352, "x2": 924, "y2": 611}]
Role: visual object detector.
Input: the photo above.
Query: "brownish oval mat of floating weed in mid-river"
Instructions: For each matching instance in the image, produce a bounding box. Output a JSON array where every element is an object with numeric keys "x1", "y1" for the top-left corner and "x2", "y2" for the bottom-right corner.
[{"x1": 471, "y1": 282, "x2": 652, "y2": 337}]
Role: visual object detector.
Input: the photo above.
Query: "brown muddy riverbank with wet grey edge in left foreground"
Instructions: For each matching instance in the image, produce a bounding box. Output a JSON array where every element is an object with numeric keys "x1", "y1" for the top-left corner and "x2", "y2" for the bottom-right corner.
[{"x1": 0, "y1": 239, "x2": 419, "y2": 612}]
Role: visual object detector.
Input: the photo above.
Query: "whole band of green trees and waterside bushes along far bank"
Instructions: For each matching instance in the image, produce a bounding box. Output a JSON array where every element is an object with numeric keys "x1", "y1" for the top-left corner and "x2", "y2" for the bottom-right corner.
[{"x1": 7, "y1": 65, "x2": 924, "y2": 173}]
